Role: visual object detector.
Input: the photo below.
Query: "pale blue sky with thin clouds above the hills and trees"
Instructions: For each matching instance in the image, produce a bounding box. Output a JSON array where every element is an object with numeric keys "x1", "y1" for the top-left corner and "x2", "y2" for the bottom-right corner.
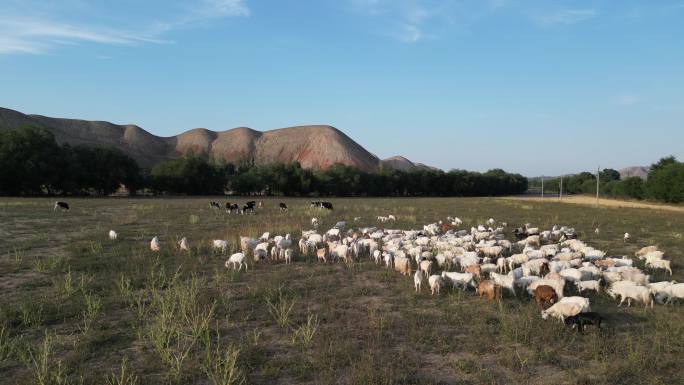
[{"x1": 0, "y1": 0, "x2": 684, "y2": 176}]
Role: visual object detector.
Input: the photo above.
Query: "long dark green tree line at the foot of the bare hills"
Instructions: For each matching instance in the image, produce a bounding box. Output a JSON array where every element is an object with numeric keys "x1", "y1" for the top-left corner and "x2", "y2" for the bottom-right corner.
[{"x1": 0, "y1": 127, "x2": 527, "y2": 196}]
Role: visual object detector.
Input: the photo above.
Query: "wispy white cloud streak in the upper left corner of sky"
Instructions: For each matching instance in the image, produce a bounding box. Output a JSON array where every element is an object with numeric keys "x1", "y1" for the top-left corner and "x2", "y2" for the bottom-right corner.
[{"x1": 0, "y1": 0, "x2": 250, "y2": 54}]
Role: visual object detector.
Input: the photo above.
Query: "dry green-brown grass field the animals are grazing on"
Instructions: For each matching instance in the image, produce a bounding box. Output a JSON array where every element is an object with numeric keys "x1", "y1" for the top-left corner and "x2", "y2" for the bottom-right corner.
[{"x1": 0, "y1": 198, "x2": 684, "y2": 384}]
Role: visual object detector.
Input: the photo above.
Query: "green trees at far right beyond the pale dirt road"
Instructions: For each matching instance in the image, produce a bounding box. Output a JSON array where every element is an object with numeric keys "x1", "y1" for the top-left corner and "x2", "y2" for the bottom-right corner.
[{"x1": 530, "y1": 156, "x2": 684, "y2": 203}]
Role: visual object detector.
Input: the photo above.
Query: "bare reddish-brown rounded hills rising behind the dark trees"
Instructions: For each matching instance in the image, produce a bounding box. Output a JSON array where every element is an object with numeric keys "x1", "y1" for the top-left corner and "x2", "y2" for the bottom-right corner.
[{"x1": 0, "y1": 108, "x2": 429, "y2": 171}]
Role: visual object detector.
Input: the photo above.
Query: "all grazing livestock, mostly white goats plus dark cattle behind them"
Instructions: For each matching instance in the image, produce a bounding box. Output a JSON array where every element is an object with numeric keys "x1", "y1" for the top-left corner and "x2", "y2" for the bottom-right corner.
[{"x1": 56, "y1": 201, "x2": 684, "y2": 331}]
